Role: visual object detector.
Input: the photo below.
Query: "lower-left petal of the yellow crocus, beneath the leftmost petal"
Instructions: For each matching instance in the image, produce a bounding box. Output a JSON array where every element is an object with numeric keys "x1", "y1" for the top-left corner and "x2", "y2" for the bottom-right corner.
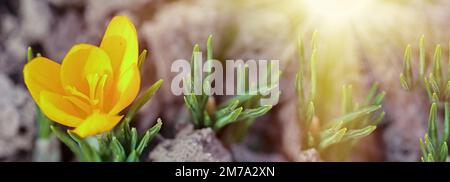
[{"x1": 38, "y1": 91, "x2": 83, "y2": 127}]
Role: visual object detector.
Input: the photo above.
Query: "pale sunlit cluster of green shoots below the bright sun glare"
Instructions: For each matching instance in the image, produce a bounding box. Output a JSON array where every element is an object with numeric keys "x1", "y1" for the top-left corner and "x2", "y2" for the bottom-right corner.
[{"x1": 296, "y1": 32, "x2": 385, "y2": 161}]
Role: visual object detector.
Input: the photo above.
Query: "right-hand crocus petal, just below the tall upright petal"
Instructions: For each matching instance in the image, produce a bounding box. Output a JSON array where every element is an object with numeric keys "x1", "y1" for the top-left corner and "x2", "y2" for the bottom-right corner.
[{"x1": 109, "y1": 66, "x2": 141, "y2": 114}]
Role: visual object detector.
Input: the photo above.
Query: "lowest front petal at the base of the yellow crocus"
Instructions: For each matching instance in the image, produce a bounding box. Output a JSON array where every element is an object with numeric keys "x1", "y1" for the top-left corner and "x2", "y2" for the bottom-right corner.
[{"x1": 72, "y1": 112, "x2": 123, "y2": 138}]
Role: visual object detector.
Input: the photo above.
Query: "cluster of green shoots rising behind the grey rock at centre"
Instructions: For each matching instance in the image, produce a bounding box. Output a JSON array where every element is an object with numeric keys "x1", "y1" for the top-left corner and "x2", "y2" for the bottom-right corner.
[{"x1": 183, "y1": 36, "x2": 276, "y2": 139}]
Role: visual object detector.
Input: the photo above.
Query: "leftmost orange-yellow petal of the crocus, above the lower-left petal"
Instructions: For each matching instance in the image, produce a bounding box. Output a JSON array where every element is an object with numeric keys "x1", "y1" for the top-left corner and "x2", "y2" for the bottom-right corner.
[{"x1": 23, "y1": 57, "x2": 64, "y2": 104}]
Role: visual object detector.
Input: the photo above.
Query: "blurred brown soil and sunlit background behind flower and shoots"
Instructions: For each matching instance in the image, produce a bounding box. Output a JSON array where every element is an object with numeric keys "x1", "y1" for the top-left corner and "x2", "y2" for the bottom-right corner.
[{"x1": 0, "y1": 0, "x2": 450, "y2": 161}]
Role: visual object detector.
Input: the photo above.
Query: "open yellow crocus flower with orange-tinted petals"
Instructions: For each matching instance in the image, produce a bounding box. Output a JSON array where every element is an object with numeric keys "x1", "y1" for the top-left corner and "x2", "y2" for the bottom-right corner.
[{"x1": 23, "y1": 16, "x2": 141, "y2": 138}]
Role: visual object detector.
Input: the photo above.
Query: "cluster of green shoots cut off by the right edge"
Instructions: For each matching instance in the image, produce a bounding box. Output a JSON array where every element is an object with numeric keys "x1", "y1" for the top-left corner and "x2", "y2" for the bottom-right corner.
[{"x1": 400, "y1": 36, "x2": 450, "y2": 162}]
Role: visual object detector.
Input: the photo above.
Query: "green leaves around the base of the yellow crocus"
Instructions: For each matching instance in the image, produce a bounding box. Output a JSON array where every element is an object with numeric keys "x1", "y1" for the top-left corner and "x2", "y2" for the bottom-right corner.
[{"x1": 28, "y1": 48, "x2": 163, "y2": 162}]
